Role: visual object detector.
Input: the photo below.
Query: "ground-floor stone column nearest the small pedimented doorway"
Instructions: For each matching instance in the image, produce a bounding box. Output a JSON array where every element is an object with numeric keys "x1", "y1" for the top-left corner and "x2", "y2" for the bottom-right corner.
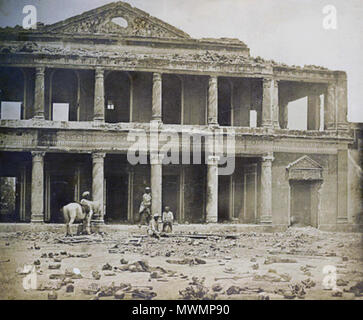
[{"x1": 260, "y1": 153, "x2": 274, "y2": 224}]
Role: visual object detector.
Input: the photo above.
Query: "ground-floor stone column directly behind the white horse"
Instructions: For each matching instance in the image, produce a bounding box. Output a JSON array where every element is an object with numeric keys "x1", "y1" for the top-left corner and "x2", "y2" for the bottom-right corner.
[{"x1": 92, "y1": 153, "x2": 106, "y2": 224}]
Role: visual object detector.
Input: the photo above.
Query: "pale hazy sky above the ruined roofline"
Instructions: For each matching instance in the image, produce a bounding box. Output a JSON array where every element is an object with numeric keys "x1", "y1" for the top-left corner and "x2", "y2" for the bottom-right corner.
[{"x1": 0, "y1": 0, "x2": 363, "y2": 122}]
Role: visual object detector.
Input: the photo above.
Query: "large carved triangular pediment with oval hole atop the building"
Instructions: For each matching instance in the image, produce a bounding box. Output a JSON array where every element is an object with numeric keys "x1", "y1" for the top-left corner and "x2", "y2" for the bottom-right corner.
[{"x1": 46, "y1": 1, "x2": 190, "y2": 38}]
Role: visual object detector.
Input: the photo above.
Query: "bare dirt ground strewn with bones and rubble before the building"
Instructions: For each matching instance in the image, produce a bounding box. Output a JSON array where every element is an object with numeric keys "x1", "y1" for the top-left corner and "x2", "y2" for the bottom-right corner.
[{"x1": 0, "y1": 227, "x2": 363, "y2": 300}]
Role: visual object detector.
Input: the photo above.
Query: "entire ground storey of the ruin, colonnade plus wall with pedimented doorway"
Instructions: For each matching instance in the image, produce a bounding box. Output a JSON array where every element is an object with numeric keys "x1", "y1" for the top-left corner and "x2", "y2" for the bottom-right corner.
[{"x1": 0, "y1": 151, "x2": 362, "y2": 230}]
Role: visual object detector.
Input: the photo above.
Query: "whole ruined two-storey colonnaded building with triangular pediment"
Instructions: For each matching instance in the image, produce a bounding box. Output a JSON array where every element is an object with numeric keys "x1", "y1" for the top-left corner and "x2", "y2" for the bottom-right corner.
[{"x1": 0, "y1": 2, "x2": 361, "y2": 230}]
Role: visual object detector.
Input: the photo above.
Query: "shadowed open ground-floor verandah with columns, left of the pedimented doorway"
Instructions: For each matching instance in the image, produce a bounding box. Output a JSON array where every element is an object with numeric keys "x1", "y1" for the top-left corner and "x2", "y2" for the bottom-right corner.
[{"x1": 1, "y1": 152, "x2": 272, "y2": 223}]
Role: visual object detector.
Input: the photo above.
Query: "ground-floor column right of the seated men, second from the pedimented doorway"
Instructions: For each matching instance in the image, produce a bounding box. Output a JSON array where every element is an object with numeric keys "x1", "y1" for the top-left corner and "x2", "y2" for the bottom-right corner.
[{"x1": 206, "y1": 156, "x2": 219, "y2": 223}]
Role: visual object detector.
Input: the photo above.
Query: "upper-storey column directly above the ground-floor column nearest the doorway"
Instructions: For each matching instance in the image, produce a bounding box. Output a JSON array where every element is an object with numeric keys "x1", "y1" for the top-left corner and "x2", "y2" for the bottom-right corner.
[{"x1": 262, "y1": 78, "x2": 276, "y2": 128}]
